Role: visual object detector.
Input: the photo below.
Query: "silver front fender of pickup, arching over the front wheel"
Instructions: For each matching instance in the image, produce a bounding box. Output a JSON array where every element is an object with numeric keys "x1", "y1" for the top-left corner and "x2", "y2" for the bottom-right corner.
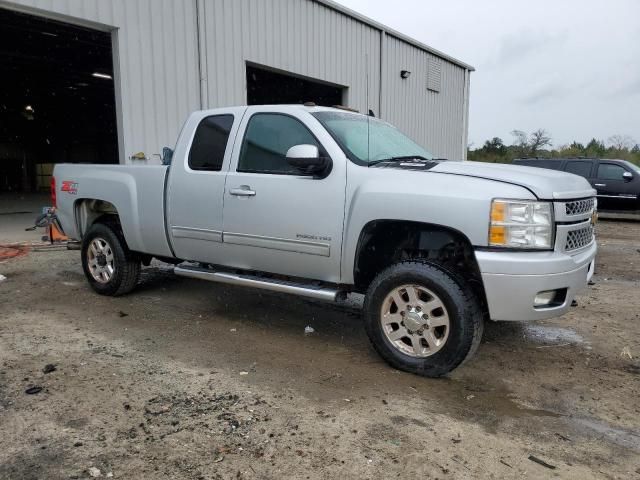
[{"x1": 341, "y1": 164, "x2": 535, "y2": 284}]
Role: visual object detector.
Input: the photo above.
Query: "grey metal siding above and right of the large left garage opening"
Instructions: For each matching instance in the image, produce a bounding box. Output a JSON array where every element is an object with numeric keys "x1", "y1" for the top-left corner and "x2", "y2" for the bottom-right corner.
[{"x1": 0, "y1": 0, "x2": 200, "y2": 163}]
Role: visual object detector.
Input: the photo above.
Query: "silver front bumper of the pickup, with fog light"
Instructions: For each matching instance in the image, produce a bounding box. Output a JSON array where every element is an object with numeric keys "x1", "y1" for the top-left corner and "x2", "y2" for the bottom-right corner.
[{"x1": 475, "y1": 242, "x2": 597, "y2": 321}]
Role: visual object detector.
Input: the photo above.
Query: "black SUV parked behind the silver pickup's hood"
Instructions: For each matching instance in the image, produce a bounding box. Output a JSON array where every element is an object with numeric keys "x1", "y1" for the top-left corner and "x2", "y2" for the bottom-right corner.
[{"x1": 513, "y1": 158, "x2": 640, "y2": 210}]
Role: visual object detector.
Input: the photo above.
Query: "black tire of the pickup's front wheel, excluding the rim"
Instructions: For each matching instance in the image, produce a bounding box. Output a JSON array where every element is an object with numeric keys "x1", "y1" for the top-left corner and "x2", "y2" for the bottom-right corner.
[{"x1": 364, "y1": 261, "x2": 484, "y2": 377}]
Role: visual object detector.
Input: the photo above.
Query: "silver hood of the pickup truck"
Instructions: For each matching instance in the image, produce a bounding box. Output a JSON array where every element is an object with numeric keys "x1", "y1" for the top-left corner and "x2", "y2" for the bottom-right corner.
[{"x1": 431, "y1": 161, "x2": 596, "y2": 200}]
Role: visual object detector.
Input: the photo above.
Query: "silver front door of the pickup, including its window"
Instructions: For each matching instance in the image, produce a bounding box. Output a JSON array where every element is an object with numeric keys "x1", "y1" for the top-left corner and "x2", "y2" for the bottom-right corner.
[{"x1": 223, "y1": 107, "x2": 346, "y2": 283}]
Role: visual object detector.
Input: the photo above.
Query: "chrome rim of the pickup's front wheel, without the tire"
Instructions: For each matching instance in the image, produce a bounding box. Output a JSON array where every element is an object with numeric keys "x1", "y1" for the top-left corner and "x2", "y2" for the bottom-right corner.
[{"x1": 380, "y1": 285, "x2": 451, "y2": 358}]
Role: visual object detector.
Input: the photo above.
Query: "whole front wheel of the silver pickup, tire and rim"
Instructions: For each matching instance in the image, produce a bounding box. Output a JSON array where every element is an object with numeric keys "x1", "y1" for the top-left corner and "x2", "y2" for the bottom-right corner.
[{"x1": 364, "y1": 261, "x2": 484, "y2": 377}]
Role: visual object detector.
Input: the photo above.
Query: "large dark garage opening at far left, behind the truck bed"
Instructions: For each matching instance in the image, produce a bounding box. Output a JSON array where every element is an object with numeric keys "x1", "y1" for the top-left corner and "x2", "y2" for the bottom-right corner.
[{"x1": 0, "y1": 8, "x2": 118, "y2": 192}]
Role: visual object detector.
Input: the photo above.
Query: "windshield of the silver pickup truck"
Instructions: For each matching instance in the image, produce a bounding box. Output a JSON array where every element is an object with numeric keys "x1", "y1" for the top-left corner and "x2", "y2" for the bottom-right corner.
[{"x1": 313, "y1": 111, "x2": 433, "y2": 165}]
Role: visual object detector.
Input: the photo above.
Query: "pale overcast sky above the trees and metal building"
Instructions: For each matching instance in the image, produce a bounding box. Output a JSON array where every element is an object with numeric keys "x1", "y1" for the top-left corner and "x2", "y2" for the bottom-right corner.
[{"x1": 338, "y1": 0, "x2": 640, "y2": 148}]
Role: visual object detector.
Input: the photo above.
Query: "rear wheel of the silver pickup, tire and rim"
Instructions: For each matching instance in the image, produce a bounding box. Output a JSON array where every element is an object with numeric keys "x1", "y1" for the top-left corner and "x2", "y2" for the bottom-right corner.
[{"x1": 82, "y1": 223, "x2": 140, "y2": 296}]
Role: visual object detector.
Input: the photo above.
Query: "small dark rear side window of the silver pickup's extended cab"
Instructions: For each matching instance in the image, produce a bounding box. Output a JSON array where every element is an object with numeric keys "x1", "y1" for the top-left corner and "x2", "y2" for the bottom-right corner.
[{"x1": 189, "y1": 115, "x2": 233, "y2": 171}]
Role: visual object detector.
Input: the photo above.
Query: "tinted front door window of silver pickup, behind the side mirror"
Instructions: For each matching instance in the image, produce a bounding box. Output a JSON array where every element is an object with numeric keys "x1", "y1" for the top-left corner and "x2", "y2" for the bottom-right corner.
[{"x1": 238, "y1": 113, "x2": 322, "y2": 174}]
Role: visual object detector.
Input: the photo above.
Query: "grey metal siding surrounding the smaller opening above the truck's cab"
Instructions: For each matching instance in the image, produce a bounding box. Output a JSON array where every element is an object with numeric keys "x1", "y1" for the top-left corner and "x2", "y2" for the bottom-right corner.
[{"x1": 201, "y1": 0, "x2": 380, "y2": 115}]
